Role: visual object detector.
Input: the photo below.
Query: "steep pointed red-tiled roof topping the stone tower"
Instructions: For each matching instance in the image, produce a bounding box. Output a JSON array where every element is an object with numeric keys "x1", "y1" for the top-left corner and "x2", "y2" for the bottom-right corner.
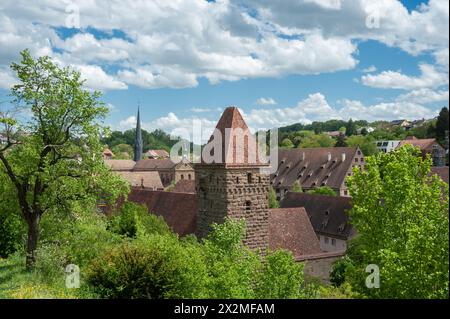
[{"x1": 202, "y1": 107, "x2": 262, "y2": 166}]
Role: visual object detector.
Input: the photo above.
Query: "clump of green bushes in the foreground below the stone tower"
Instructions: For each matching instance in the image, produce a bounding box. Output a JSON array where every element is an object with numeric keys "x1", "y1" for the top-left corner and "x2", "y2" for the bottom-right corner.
[{"x1": 86, "y1": 219, "x2": 306, "y2": 299}]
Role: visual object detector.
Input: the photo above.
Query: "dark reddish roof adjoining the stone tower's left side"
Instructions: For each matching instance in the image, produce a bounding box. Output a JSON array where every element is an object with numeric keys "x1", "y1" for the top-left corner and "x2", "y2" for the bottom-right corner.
[{"x1": 128, "y1": 189, "x2": 197, "y2": 236}]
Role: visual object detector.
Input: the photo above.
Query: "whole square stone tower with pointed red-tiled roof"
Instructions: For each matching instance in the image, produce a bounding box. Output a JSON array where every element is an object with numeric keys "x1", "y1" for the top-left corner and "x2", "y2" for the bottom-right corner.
[{"x1": 195, "y1": 107, "x2": 269, "y2": 249}]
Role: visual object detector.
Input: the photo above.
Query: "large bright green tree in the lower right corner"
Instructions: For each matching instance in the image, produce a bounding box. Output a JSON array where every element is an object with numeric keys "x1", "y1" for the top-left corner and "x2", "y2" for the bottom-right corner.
[{"x1": 345, "y1": 145, "x2": 449, "y2": 298}]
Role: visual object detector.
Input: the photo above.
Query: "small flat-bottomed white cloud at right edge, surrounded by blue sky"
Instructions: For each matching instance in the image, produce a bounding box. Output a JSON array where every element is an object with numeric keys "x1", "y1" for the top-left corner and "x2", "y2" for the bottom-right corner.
[{"x1": 361, "y1": 63, "x2": 448, "y2": 90}]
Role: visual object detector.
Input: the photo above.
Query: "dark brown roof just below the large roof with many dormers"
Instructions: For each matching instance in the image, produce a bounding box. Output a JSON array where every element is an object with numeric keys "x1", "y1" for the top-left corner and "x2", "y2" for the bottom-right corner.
[{"x1": 280, "y1": 192, "x2": 354, "y2": 240}]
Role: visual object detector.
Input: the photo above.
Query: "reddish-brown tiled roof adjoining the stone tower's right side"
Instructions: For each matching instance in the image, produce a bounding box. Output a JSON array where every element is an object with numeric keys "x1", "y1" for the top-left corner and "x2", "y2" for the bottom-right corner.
[{"x1": 269, "y1": 207, "x2": 321, "y2": 258}]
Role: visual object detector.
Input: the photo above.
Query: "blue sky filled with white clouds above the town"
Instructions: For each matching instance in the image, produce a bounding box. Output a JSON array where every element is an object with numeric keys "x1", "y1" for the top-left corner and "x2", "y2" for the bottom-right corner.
[{"x1": 0, "y1": 0, "x2": 449, "y2": 139}]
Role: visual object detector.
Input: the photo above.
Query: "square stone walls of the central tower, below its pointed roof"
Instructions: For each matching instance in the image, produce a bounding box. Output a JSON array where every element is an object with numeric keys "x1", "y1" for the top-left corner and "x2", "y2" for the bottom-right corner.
[{"x1": 195, "y1": 165, "x2": 269, "y2": 249}]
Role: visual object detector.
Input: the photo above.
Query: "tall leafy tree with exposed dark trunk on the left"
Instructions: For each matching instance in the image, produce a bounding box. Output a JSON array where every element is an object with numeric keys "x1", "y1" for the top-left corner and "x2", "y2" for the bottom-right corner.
[{"x1": 0, "y1": 50, "x2": 126, "y2": 270}]
